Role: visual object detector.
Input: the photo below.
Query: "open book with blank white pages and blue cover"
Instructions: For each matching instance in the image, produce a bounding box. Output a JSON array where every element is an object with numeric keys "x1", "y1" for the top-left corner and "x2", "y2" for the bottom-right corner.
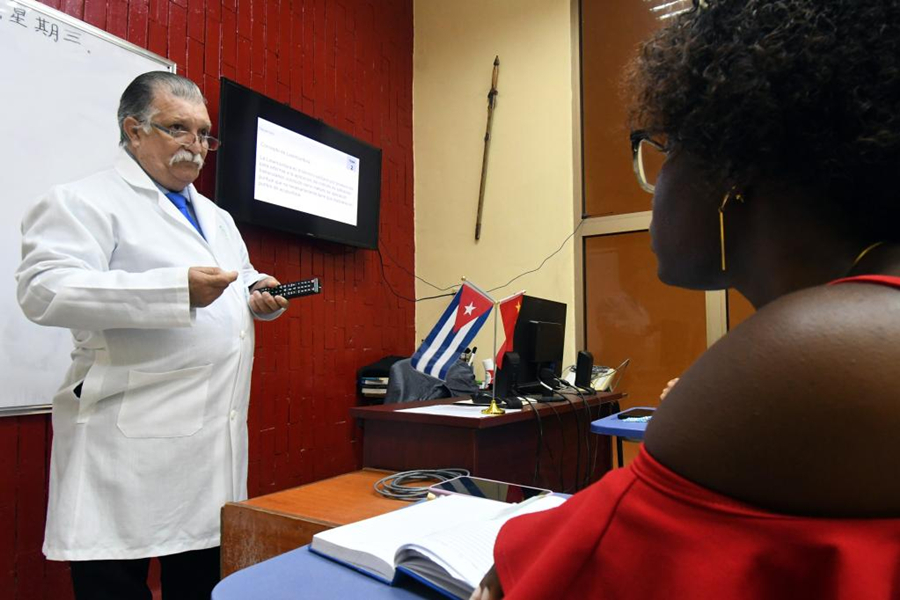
[{"x1": 310, "y1": 495, "x2": 565, "y2": 598}]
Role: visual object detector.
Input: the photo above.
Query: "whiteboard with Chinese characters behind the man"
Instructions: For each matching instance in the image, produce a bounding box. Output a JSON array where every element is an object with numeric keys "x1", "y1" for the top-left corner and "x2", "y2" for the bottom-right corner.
[{"x1": 0, "y1": 0, "x2": 175, "y2": 414}]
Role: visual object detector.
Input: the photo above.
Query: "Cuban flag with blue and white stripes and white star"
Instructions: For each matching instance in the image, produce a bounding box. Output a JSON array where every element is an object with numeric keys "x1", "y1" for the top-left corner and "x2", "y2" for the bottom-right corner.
[{"x1": 412, "y1": 283, "x2": 494, "y2": 380}]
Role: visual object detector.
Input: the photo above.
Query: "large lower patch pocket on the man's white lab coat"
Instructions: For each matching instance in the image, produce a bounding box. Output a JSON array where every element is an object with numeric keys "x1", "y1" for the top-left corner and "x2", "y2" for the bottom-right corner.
[{"x1": 116, "y1": 365, "x2": 212, "y2": 438}]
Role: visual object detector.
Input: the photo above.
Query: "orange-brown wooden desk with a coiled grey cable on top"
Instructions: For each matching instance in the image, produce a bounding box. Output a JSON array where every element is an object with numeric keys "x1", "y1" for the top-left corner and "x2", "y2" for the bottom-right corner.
[{"x1": 222, "y1": 469, "x2": 409, "y2": 577}]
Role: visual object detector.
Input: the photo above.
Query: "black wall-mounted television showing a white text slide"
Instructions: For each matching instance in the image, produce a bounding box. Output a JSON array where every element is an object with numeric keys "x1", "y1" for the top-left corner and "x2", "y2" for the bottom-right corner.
[{"x1": 216, "y1": 77, "x2": 381, "y2": 249}]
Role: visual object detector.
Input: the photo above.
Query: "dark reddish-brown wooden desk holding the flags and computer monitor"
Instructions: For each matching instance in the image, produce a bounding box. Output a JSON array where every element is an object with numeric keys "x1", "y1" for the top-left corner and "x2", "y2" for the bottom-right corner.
[{"x1": 350, "y1": 393, "x2": 623, "y2": 491}]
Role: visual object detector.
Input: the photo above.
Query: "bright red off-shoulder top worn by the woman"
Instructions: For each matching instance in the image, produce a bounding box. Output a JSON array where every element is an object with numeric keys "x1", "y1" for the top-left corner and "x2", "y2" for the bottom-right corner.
[{"x1": 494, "y1": 276, "x2": 900, "y2": 600}]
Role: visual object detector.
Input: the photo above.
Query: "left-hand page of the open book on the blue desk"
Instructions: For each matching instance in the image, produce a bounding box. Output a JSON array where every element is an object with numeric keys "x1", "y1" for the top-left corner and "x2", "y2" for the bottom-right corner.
[{"x1": 310, "y1": 494, "x2": 509, "y2": 581}]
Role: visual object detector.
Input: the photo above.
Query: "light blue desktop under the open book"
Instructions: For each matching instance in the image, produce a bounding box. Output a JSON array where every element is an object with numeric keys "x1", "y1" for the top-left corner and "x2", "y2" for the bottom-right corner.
[{"x1": 212, "y1": 546, "x2": 447, "y2": 600}]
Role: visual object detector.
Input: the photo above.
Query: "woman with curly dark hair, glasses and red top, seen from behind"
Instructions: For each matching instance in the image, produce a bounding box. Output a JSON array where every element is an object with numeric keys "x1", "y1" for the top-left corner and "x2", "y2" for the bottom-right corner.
[{"x1": 473, "y1": 0, "x2": 900, "y2": 599}]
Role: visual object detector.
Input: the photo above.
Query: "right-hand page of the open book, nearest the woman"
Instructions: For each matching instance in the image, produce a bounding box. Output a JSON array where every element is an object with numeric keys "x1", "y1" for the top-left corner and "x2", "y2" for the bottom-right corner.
[{"x1": 394, "y1": 496, "x2": 566, "y2": 593}]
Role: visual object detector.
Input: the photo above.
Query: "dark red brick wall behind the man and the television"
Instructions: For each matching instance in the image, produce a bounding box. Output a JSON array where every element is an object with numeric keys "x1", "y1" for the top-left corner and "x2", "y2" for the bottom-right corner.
[{"x1": 0, "y1": 0, "x2": 415, "y2": 600}]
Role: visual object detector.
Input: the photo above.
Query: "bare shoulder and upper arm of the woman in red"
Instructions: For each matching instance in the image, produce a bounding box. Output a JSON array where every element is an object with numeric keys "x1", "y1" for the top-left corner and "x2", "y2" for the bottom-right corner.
[{"x1": 646, "y1": 283, "x2": 900, "y2": 516}]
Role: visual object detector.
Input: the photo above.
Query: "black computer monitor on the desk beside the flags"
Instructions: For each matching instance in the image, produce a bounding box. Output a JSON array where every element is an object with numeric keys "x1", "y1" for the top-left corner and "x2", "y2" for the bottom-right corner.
[{"x1": 497, "y1": 296, "x2": 566, "y2": 394}]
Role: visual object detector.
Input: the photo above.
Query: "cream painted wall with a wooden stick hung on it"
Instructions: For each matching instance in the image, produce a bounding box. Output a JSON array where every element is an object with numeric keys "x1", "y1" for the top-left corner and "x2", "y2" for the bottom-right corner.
[{"x1": 413, "y1": 0, "x2": 581, "y2": 377}]
